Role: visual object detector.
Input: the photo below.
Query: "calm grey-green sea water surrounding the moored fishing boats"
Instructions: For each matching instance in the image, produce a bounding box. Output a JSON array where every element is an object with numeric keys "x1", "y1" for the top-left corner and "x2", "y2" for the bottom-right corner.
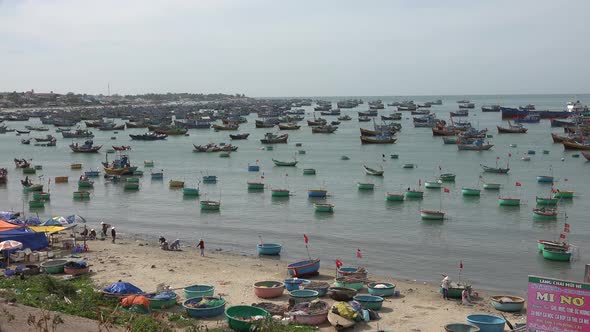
[{"x1": 0, "y1": 95, "x2": 590, "y2": 291}]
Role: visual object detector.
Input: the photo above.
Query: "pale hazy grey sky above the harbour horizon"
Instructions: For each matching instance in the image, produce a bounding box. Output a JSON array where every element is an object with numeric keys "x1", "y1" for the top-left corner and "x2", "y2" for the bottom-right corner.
[{"x1": 0, "y1": 0, "x2": 590, "y2": 96}]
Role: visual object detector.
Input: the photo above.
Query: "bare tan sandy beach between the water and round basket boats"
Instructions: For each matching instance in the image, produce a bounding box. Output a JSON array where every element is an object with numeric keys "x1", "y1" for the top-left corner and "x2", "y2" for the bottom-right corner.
[{"x1": 71, "y1": 235, "x2": 526, "y2": 331}]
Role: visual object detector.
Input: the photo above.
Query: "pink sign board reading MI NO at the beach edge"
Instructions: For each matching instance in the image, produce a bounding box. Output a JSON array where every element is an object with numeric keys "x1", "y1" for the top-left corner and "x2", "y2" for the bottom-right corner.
[{"x1": 527, "y1": 276, "x2": 590, "y2": 332}]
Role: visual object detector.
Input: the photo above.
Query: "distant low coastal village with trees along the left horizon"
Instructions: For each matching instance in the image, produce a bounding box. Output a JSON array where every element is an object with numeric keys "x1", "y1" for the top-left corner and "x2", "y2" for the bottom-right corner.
[{"x1": 0, "y1": 90, "x2": 247, "y2": 109}]
